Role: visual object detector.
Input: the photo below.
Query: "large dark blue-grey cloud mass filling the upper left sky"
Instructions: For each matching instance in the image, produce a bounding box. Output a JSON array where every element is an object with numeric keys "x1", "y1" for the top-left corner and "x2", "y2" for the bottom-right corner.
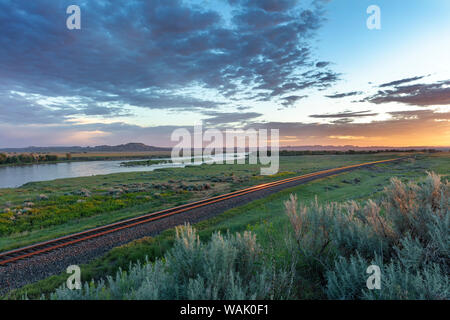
[{"x1": 0, "y1": 0, "x2": 338, "y2": 122}]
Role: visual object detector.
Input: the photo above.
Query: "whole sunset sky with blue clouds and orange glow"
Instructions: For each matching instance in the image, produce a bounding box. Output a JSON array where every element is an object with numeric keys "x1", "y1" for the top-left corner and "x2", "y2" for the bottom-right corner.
[{"x1": 0, "y1": 0, "x2": 450, "y2": 147}]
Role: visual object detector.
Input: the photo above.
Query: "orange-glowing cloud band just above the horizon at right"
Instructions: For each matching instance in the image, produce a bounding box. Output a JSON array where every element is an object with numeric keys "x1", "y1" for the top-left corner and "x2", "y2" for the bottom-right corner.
[{"x1": 248, "y1": 109, "x2": 450, "y2": 146}]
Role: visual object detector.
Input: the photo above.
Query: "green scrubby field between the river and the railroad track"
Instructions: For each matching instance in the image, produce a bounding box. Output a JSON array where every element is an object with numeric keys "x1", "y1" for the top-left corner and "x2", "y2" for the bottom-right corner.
[{"x1": 0, "y1": 154, "x2": 412, "y2": 251}]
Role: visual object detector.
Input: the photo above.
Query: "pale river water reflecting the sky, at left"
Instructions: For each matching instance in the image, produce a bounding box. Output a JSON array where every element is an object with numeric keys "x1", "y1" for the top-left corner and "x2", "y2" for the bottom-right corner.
[{"x1": 0, "y1": 154, "x2": 245, "y2": 188}]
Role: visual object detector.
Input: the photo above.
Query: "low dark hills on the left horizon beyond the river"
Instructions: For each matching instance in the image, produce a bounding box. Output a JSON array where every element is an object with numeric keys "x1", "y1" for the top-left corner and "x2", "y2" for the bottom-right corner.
[{"x1": 0, "y1": 143, "x2": 172, "y2": 153}]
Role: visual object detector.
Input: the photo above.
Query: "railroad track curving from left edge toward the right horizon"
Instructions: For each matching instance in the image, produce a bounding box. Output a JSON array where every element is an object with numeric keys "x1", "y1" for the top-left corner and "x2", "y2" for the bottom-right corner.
[{"x1": 0, "y1": 157, "x2": 406, "y2": 266}]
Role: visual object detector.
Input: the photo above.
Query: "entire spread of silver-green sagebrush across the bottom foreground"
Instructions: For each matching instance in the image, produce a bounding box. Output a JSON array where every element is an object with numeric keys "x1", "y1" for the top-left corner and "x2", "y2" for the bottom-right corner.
[{"x1": 45, "y1": 173, "x2": 450, "y2": 299}]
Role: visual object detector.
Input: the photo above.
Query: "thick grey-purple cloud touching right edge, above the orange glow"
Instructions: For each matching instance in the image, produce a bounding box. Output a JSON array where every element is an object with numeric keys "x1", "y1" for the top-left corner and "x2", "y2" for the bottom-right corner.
[{"x1": 363, "y1": 80, "x2": 450, "y2": 107}]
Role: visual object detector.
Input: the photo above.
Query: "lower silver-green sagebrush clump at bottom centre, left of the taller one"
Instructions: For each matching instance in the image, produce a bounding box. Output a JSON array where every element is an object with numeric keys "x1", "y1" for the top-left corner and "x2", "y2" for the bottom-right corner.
[{"x1": 51, "y1": 225, "x2": 292, "y2": 299}]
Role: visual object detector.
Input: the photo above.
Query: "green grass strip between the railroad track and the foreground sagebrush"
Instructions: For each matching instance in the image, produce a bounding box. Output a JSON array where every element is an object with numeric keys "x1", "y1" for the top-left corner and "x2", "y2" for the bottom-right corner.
[{"x1": 5, "y1": 154, "x2": 450, "y2": 299}]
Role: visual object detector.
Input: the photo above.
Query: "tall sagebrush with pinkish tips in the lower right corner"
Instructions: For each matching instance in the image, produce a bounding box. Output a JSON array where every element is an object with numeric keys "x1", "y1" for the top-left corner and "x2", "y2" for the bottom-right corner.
[{"x1": 285, "y1": 173, "x2": 450, "y2": 299}]
